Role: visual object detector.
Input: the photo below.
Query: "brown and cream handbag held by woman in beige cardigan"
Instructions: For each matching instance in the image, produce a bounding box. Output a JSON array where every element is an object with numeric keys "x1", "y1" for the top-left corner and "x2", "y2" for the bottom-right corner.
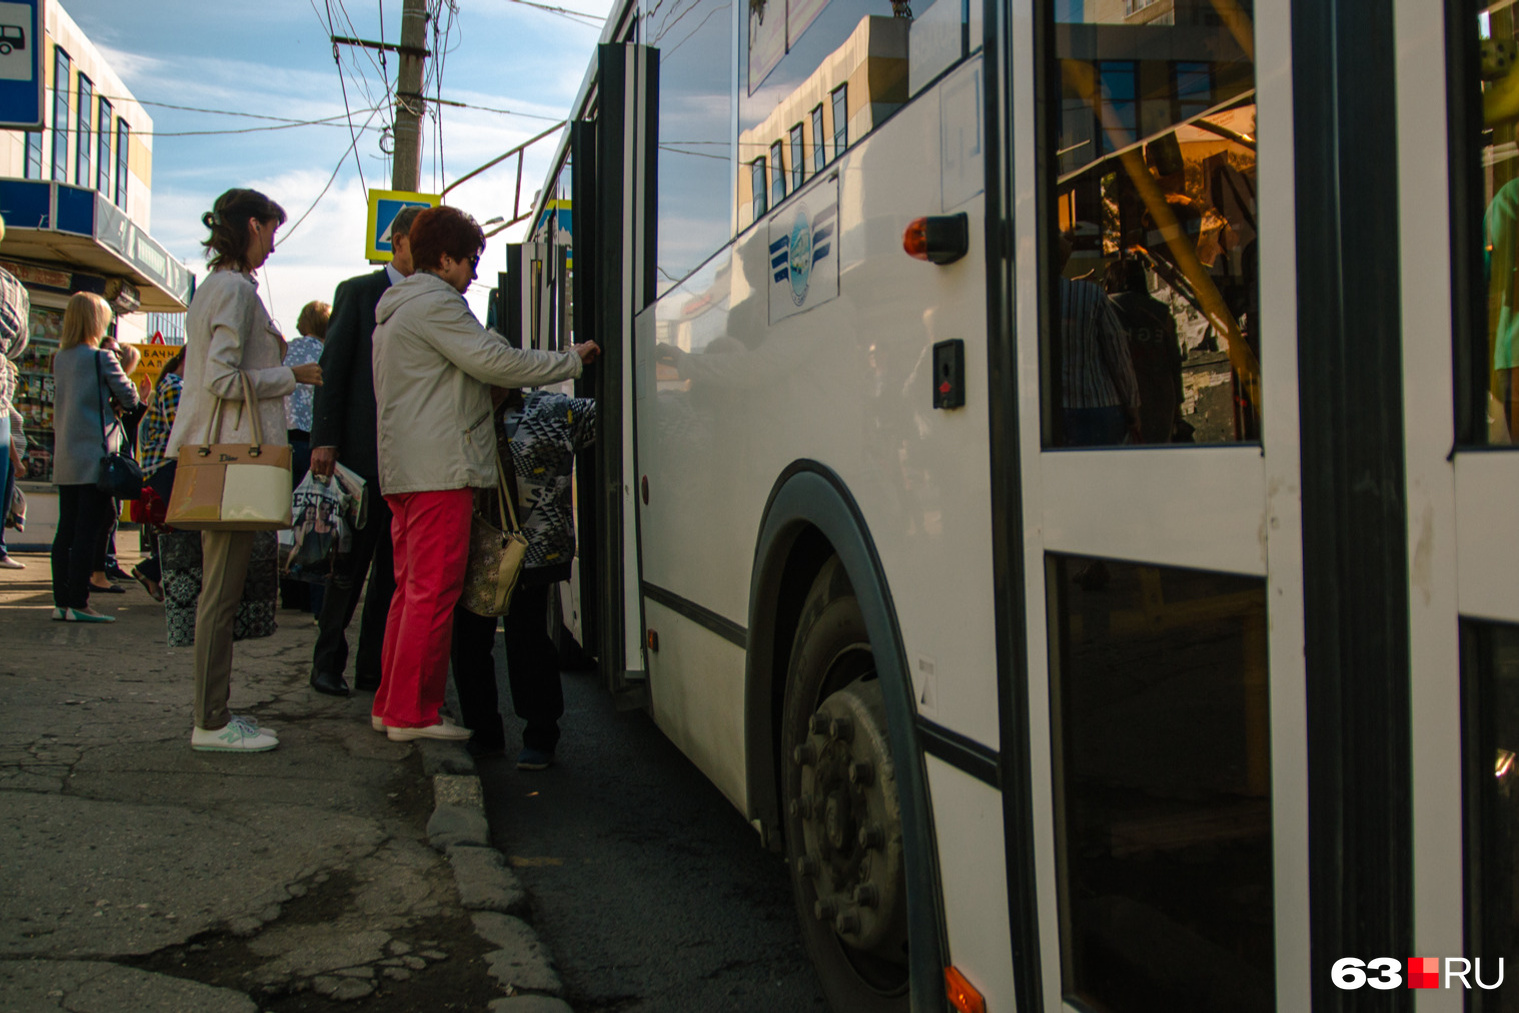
[{"x1": 166, "y1": 372, "x2": 290, "y2": 532}]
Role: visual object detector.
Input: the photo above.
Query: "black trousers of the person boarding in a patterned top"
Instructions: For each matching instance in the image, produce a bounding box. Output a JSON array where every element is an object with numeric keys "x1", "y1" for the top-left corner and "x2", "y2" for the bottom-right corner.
[{"x1": 453, "y1": 585, "x2": 565, "y2": 753}]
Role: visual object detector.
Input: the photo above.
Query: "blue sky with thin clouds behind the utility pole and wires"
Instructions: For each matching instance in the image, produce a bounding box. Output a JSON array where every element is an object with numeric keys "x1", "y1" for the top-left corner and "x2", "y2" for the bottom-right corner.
[{"x1": 55, "y1": 0, "x2": 611, "y2": 329}]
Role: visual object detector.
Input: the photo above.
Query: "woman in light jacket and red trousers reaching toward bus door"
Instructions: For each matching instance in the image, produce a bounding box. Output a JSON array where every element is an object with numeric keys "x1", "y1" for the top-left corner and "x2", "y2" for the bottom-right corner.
[{"x1": 372, "y1": 208, "x2": 600, "y2": 741}]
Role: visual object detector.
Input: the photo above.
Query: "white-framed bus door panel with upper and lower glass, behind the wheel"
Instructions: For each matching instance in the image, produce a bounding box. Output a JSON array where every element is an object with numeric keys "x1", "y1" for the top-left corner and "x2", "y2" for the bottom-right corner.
[{"x1": 990, "y1": 0, "x2": 1309, "y2": 1013}]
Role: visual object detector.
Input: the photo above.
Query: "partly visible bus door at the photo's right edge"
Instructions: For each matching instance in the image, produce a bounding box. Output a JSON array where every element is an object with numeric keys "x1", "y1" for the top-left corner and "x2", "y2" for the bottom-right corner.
[{"x1": 1403, "y1": 0, "x2": 1519, "y2": 1011}]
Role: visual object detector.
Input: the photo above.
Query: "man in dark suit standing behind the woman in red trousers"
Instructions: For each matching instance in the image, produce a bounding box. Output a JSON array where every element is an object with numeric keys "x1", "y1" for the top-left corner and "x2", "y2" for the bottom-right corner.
[{"x1": 311, "y1": 207, "x2": 424, "y2": 697}]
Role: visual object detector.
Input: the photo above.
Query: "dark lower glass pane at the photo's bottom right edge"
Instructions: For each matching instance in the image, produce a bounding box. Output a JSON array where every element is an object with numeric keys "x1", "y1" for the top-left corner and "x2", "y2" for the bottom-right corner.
[{"x1": 1461, "y1": 621, "x2": 1519, "y2": 1010}]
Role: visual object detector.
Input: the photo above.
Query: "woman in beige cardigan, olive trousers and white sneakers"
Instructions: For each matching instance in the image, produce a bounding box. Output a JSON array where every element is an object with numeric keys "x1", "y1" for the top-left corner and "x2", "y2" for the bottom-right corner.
[{"x1": 167, "y1": 190, "x2": 322, "y2": 752}]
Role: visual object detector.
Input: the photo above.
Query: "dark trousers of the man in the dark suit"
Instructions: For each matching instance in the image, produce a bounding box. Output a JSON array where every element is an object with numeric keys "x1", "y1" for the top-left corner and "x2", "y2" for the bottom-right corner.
[{"x1": 311, "y1": 477, "x2": 395, "y2": 688}]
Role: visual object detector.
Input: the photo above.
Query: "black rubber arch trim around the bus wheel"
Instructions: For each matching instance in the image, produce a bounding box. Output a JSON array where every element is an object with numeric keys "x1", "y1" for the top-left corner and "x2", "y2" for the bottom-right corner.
[{"x1": 744, "y1": 460, "x2": 949, "y2": 1013}]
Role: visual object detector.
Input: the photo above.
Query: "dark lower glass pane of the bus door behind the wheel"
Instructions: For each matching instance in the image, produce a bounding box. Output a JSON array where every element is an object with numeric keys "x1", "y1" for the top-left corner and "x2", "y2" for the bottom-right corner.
[{"x1": 1048, "y1": 556, "x2": 1276, "y2": 1013}]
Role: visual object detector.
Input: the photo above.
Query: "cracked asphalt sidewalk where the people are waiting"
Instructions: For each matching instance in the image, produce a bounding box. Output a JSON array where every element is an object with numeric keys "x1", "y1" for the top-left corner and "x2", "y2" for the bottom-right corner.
[{"x1": 0, "y1": 546, "x2": 568, "y2": 1013}]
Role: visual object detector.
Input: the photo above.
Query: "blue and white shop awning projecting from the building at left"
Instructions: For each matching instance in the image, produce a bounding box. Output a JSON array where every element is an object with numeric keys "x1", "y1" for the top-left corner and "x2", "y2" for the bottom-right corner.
[{"x1": 0, "y1": 178, "x2": 194, "y2": 313}]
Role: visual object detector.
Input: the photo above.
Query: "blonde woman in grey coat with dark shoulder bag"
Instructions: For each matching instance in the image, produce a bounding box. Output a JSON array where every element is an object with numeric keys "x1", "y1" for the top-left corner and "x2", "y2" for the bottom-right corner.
[{"x1": 53, "y1": 292, "x2": 138, "y2": 623}]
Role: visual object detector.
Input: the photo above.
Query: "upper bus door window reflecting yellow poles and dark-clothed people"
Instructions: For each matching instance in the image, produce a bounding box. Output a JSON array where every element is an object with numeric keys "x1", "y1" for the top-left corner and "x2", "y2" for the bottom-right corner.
[{"x1": 1044, "y1": 0, "x2": 1261, "y2": 447}]
